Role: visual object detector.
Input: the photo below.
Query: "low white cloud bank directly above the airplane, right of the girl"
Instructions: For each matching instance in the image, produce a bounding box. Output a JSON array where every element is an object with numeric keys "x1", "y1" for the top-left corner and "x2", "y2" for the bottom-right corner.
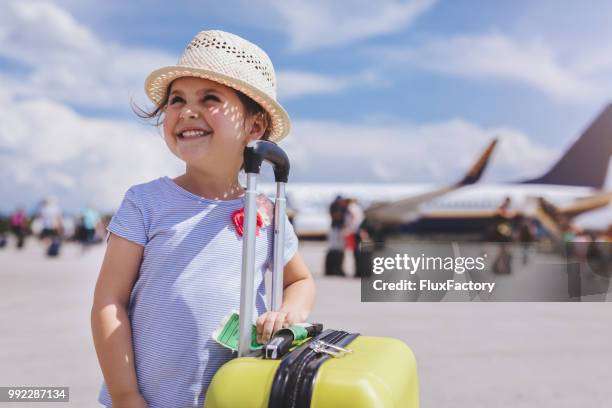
[{"x1": 283, "y1": 119, "x2": 557, "y2": 183}]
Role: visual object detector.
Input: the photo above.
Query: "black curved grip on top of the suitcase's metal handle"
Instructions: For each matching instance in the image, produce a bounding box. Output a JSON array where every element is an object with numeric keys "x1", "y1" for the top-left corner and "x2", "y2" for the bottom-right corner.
[{"x1": 244, "y1": 140, "x2": 289, "y2": 183}]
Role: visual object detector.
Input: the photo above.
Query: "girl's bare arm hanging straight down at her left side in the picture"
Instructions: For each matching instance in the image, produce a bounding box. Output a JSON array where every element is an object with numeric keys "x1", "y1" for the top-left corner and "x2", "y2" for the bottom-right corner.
[{"x1": 91, "y1": 234, "x2": 147, "y2": 407}]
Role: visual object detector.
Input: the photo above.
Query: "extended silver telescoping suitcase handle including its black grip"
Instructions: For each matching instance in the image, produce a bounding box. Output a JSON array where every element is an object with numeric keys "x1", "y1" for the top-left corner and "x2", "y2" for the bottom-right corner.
[{"x1": 238, "y1": 140, "x2": 289, "y2": 357}]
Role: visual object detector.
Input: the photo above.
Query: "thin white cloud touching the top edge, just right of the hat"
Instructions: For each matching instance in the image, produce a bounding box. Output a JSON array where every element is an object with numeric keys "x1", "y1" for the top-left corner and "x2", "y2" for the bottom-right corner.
[{"x1": 269, "y1": 0, "x2": 436, "y2": 51}]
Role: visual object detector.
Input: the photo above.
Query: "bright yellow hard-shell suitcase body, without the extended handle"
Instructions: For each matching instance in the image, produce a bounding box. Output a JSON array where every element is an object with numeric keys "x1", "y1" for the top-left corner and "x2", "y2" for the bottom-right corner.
[{"x1": 204, "y1": 331, "x2": 419, "y2": 408}]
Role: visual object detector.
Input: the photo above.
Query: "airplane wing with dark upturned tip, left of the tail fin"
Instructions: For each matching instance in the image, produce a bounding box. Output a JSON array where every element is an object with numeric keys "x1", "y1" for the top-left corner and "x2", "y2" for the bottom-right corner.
[{"x1": 365, "y1": 139, "x2": 497, "y2": 224}]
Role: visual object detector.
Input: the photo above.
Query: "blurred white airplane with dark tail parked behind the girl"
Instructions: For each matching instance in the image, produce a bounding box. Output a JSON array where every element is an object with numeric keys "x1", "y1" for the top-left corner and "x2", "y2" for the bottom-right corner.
[{"x1": 262, "y1": 104, "x2": 612, "y2": 237}]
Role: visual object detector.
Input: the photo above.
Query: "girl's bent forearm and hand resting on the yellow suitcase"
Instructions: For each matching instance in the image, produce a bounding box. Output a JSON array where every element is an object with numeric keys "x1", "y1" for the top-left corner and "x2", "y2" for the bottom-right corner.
[{"x1": 257, "y1": 252, "x2": 315, "y2": 343}]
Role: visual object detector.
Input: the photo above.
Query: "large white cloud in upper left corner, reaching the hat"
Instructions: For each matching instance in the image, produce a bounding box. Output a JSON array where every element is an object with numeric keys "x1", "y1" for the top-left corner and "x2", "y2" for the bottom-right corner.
[{"x1": 0, "y1": 1, "x2": 176, "y2": 109}]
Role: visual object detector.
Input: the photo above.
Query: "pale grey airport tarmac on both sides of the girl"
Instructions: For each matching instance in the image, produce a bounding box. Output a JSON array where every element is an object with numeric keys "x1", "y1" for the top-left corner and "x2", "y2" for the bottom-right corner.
[{"x1": 0, "y1": 240, "x2": 612, "y2": 408}]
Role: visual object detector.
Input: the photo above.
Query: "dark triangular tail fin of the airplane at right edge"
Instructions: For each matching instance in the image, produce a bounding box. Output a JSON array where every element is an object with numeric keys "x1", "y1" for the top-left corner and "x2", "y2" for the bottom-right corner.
[{"x1": 521, "y1": 104, "x2": 612, "y2": 189}]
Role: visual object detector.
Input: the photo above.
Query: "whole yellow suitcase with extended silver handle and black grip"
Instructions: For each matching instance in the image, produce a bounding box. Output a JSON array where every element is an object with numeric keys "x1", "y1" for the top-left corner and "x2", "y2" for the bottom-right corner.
[{"x1": 205, "y1": 141, "x2": 419, "y2": 408}]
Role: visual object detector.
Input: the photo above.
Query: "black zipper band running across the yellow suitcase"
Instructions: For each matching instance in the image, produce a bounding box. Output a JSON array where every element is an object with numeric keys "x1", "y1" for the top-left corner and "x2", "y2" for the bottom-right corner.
[{"x1": 268, "y1": 330, "x2": 358, "y2": 408}]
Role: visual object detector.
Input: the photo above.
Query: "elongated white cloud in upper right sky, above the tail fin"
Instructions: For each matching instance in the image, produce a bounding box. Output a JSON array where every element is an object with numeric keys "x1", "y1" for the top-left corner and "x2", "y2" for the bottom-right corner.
[{"x1": 384, "y1": 34, "x2": 597, "y2": 101}]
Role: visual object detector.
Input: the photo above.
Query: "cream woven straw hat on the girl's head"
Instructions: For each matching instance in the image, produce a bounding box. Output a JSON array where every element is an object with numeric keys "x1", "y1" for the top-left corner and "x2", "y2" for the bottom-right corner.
[{"x1": 145, "y1": 30, "x2": 291, "y2": 142}]
